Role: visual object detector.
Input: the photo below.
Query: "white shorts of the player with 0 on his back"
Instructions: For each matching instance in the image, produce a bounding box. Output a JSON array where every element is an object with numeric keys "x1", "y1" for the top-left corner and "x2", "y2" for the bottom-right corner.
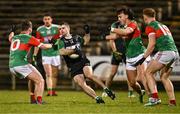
[{"x1": 10, "y1": 64, "x2": 36, "y2": 79}]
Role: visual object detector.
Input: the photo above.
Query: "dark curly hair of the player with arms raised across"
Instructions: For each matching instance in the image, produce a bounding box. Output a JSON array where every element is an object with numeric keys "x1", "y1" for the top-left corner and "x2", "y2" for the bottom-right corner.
[{"x1": 116, "y1": 6, "x2": 134, "y2": 20}]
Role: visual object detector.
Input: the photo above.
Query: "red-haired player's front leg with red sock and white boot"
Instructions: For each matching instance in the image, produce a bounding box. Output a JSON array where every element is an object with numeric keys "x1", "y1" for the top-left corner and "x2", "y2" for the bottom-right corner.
[{"x1": 145, "y1": 60, "x2": 164, "y2": 106}]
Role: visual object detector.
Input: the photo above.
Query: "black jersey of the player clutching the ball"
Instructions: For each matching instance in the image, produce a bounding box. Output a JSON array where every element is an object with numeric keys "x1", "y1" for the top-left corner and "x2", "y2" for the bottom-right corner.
[{"x1": 59, "y1": 35, "x2": 86, "y2": 68}]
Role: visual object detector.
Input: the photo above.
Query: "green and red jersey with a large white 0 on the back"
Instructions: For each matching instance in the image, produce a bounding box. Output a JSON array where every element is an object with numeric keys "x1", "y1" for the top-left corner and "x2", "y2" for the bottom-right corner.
[{"x1": 9, "y1": 34, "x2": 41, "y2": 68}]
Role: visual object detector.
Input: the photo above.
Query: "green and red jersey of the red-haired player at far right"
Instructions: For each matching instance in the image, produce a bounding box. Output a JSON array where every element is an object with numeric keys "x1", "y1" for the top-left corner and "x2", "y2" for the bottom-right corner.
[{"x1": 145, "y1": 21, "x2": 177, "y2": 51}]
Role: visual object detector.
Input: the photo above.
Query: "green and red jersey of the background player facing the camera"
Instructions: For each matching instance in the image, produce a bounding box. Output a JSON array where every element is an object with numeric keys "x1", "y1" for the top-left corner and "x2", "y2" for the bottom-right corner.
[{"x1": 36, "y1": 24, "x2": 60, "y2": 57}]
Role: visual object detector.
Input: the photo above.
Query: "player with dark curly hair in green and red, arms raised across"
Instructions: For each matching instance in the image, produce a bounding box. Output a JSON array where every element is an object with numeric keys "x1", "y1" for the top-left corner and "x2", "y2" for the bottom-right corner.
[{"x1": 106, "y1": 7, "x2": 150, "y2": 103}]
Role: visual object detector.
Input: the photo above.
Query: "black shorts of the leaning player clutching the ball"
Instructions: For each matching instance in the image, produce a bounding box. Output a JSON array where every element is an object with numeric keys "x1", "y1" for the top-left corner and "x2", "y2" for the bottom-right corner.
[{"x1": 70, "y1": 58, "x2": 90, "y2": 78}]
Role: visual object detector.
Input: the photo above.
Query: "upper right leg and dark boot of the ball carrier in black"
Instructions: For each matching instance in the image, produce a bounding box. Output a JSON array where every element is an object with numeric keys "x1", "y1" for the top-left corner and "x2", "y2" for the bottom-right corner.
[{"x1": 83, "y1": 66, "x2": 115, "y2": 100}]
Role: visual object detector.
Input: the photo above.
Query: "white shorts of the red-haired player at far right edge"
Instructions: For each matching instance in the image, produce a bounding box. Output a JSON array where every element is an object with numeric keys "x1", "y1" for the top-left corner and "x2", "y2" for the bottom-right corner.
[{"x1": 153, "y1": 51, "x2": 179, "y2": 67}]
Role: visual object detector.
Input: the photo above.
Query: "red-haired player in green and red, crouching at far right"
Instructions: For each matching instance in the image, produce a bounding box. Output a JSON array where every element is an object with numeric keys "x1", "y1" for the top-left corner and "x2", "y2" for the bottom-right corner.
[{"x1": 137, "y1": 8, "x2": 179, "y2": 106}]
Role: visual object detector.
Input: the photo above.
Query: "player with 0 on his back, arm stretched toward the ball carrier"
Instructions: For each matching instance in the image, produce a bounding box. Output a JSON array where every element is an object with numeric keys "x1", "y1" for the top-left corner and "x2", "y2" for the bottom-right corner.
[{"x1": 9, "y1": 20, "x2": 52, "y2": 104}]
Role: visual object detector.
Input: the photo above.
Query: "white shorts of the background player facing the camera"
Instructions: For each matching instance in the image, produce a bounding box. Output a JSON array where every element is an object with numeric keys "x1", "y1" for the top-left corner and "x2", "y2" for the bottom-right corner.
[{"x1": 42, "y1": 55, "x2": 61, "y2": 66}]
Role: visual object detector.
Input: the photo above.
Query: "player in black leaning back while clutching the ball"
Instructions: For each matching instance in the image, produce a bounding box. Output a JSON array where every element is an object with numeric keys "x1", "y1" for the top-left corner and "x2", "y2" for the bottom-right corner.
[{"x1": 53, "y1": 23, "x2": 115, "y2": 103}]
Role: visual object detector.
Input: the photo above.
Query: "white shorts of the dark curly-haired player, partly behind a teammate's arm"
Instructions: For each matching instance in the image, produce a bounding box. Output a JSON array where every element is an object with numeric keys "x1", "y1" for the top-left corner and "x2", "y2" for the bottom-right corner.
[{"x1": 126, "y1": 53, "x2": 150, "y2": 70}]
